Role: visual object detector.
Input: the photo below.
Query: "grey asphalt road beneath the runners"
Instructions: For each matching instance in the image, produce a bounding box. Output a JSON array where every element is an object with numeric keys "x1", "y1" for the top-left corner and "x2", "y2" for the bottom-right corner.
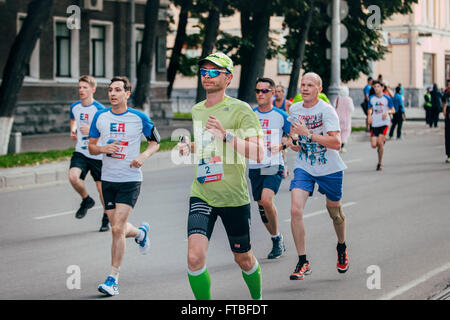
[{"x1": 0, "y1": 123, "x2": 450, "y2": 300}]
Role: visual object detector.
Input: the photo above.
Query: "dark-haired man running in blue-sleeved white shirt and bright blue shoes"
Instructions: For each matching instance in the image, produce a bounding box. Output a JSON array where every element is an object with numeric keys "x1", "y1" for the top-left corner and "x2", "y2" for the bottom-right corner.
[{"x1": 89, "y1": 77, "x2": 160, "y2": 296}]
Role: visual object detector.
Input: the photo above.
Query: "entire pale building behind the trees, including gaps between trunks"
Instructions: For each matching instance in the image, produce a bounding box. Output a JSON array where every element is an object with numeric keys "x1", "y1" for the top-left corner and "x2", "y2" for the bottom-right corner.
[{"x1": 168, "y1": 0, "x2": 450, "y2": 107}]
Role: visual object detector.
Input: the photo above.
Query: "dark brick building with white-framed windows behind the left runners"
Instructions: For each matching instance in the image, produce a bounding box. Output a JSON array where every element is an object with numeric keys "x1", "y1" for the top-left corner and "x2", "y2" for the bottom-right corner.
[{"x1": 0, "y1": 0, "x2": 170, "y2": 134}]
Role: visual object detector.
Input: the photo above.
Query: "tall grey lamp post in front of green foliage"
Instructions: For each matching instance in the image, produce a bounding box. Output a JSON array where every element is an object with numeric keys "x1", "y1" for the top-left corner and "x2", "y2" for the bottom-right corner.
[{"x1": 328, "y1": 0, "x2": 341, "y2": 104}]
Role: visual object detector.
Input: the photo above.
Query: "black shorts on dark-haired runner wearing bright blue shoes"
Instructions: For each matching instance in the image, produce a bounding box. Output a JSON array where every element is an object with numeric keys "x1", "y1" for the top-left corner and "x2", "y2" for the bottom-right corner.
[{"x1": 102, "y1": 181, "x2": 141, "y2": 210}]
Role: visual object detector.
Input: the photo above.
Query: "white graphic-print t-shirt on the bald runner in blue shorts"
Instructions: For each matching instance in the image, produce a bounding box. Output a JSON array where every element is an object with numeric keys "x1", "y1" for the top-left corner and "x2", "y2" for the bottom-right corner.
[{"x1": 289, "y1": 100, "x2": 347, "y2": 177}]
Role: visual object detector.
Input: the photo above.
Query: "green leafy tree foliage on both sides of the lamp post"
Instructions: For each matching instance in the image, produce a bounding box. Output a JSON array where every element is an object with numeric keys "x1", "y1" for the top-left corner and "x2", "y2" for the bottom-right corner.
[{"x1": 303, "y1": 0, "x2": 417, "y2": 91}]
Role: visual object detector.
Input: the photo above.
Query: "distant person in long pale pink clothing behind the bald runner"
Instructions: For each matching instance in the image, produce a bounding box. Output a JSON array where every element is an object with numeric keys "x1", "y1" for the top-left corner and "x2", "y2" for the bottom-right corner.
[{"x1": 334, "y1": 86, "x2": 355, "y2": 153}]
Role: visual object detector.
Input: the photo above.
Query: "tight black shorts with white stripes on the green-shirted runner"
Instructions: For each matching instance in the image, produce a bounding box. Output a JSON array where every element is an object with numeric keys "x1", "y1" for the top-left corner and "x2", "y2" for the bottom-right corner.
[{"x1": 187, "y1": 197, "x2": 251, "y2": 253}]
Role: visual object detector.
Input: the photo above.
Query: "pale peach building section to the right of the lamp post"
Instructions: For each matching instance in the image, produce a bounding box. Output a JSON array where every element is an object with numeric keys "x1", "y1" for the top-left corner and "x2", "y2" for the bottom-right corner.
[{"x1": 347, "y1": 0, "x2": 450, "y2": 107}]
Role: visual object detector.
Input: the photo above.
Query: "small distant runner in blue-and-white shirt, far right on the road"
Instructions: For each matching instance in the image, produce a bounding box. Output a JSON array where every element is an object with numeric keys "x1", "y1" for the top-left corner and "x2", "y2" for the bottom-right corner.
[{"x1": 367, "y1": 81, "x2": 395, "y2": 171}]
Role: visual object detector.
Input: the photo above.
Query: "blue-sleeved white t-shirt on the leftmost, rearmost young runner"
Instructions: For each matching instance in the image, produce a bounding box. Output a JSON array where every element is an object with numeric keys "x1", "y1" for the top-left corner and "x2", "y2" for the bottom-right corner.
[{"x1": 70, "y1": 100, "x2": 105, "y2": 160}]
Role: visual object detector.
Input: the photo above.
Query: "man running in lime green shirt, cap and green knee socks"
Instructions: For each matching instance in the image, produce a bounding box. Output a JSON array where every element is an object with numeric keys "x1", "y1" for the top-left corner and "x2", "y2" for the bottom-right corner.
[{"x1": 178, "y1": 52, "x2": 264, "y2": 300}]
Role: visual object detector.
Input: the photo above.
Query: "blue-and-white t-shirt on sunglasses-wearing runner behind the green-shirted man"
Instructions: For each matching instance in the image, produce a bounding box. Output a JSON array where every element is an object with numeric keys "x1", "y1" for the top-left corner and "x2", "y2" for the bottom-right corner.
[{"x1": 248, "y1": 107, "x2": 291, "y2": 169}]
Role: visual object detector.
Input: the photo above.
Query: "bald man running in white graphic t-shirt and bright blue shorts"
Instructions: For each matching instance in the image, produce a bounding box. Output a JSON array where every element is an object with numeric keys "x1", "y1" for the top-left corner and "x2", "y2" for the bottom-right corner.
[{"x1": 289, "y1": 72, "x2": 348, "y2": 280}]
